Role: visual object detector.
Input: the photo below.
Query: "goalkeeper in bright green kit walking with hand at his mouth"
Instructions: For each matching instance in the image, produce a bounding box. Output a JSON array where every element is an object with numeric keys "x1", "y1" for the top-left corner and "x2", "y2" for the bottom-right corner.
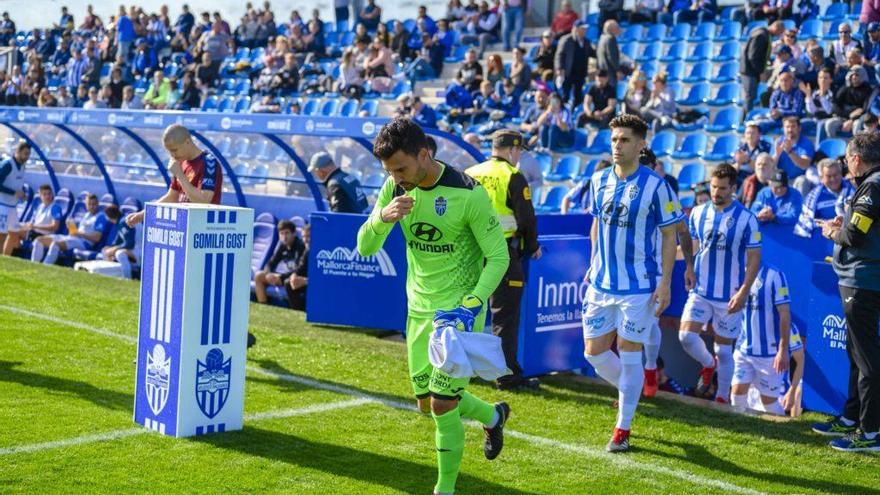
[{"x1": 358, "y1": 118, "x2": 510, "y2": 494}]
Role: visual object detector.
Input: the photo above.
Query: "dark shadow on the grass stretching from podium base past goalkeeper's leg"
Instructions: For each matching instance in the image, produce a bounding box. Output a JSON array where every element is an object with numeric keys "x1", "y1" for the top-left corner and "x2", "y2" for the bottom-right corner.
[{"x1": 195, "y1": 426, "x2": 544, "y2": 495}]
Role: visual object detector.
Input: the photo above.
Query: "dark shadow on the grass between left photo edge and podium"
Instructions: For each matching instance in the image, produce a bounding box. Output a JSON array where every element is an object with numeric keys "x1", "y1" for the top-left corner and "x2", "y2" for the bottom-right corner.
[{"x1": 0, "y1": 360, "x2": 134, "y2": 411}]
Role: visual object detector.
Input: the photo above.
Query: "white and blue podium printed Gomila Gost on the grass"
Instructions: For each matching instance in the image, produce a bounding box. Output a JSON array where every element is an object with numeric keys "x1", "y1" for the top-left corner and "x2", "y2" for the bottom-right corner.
[{"x1": 134, "y1": 203, "x2": 254, "y2": 437}]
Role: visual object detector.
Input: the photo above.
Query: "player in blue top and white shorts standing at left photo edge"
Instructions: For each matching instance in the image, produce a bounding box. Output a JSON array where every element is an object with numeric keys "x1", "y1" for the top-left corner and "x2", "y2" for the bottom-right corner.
[{"x1": 0, "y1": 141, "x2": 31, "y2": 256}]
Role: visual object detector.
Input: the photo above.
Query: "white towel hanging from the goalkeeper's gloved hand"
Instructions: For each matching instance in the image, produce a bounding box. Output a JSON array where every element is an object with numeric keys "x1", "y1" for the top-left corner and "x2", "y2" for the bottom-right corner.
[{"x1": 428, "y1": 326, "x2": 511, "y2": 381}]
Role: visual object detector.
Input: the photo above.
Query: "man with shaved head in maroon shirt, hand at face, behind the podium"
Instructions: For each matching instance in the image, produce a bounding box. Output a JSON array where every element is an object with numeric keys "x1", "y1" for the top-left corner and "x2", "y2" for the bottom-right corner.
[{"x1": 125, "y1": 124, "x2": 223, "y2": 227}]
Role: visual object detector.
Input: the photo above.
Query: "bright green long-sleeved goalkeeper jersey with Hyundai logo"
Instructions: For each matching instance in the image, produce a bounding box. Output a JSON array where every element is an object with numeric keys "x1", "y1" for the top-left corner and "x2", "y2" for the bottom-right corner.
[{"x1": 358, "y1": 165, "x2": 510, "y2": 316}]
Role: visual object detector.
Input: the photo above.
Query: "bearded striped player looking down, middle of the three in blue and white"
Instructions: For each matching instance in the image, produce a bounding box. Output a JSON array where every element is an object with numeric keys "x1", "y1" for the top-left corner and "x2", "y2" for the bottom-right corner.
[{"x1": 678, "y1": 163, "x2": 761, "y2": 403}]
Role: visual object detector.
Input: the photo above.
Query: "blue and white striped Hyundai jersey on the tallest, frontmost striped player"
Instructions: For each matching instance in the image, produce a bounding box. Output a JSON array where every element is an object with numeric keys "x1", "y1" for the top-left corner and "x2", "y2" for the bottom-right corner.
[{"x1": 590, "y1": 166, "x2": 684, "y2": 294}]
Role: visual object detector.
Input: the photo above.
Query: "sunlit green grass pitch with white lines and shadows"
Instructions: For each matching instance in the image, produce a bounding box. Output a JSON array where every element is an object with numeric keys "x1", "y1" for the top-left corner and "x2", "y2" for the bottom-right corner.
[{"x1": 0, "y1": 258, "x2": 880, "y2": 495}]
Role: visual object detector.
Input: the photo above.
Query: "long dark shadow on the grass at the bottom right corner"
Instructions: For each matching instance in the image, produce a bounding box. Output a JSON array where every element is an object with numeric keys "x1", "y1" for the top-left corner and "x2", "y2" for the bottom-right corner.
[{"x1": 639, "y1": 438, "x2": 880, "y2": 494}]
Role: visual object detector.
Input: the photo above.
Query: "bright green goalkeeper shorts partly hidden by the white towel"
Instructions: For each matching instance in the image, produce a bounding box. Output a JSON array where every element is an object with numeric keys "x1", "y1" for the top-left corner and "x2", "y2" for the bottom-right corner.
[{"x1": 406, "y1": 311, "x2": 486, "y2": 399}]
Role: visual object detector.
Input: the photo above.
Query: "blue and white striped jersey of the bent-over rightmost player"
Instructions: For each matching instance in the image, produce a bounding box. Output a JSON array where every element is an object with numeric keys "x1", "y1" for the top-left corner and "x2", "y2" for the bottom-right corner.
[{"x1": 737, "y1": 265, "x2": 800, "y2": 357}]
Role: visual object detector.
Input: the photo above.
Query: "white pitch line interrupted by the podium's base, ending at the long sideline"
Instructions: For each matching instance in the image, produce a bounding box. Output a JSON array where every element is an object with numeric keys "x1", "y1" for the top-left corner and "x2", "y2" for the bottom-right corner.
[{"x1": 0, "y1": 398, "x2": 377, "y2": 455}]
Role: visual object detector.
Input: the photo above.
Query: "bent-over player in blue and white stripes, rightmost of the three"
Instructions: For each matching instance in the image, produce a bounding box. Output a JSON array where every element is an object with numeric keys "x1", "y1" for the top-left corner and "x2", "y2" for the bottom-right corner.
[{"x1": 731, "y1": 265, "x2": 792, "y2": 415}]
